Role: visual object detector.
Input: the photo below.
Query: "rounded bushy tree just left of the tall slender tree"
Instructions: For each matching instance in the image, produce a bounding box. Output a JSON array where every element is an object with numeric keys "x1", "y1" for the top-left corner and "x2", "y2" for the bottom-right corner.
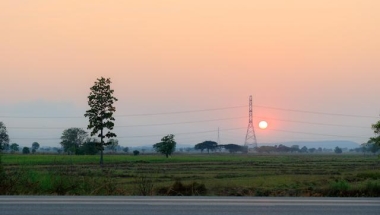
[{"x1": 61, "y1": 128, "x2": 88, "y2": 154}]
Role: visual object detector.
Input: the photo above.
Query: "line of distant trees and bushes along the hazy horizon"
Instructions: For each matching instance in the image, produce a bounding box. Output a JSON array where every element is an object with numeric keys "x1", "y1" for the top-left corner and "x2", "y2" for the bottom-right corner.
[{"x1": 0, "y1": 112, "x2": 380, "y2": 158}]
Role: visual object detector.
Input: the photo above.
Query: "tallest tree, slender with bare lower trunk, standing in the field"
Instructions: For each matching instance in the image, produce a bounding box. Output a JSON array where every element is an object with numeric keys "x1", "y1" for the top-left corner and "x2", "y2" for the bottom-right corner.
[{"x1": 84, "y1": 77, "x2": 117, "y2": 165}]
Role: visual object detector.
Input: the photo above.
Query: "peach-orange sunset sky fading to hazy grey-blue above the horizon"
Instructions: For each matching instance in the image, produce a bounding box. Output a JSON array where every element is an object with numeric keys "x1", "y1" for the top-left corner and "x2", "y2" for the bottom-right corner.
[{"x1": 0, "y1": 0, "x2": 380, "y2": 148}]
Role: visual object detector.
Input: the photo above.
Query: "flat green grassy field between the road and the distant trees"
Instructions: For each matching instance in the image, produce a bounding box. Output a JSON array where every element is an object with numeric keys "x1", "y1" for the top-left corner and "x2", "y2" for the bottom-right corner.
[{"x1": 0, "y1": 154, "x2": 380, "y2": 197}]
